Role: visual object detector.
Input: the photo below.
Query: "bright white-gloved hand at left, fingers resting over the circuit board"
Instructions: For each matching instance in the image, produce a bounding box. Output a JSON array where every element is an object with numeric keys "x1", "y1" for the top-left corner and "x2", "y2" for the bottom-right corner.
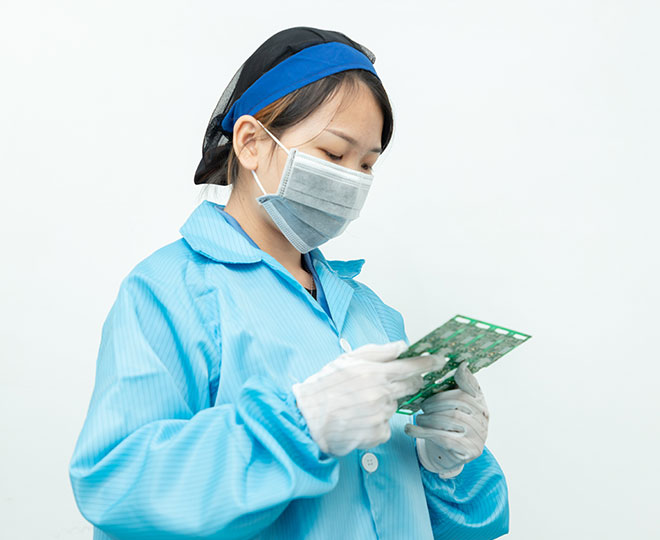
[{"x1": 292, "y1": 340, "x2": 439, "y2": 456}]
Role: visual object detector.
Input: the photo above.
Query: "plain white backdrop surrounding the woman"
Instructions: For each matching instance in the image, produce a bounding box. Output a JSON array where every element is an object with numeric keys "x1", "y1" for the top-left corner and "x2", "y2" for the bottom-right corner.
[{"x1": 0, "y1": 0, "x2": 660, "y2": 540}]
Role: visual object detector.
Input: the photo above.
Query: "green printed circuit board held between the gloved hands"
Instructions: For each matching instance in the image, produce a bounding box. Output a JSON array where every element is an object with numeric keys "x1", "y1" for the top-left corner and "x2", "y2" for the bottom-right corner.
[{"x1": 396, "y1": 315, "x2": 532, "y2": 414}]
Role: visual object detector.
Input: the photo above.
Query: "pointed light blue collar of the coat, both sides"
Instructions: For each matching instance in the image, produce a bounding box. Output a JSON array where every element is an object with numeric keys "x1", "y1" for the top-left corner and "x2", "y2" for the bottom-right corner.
[{"x1": 179, "y1": 200, "x2": 365, "y2": 278}]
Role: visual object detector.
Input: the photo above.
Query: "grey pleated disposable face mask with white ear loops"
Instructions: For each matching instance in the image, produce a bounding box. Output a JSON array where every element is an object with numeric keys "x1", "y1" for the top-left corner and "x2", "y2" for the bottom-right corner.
[{"x1": 251, "y1": 120, "x2": 373, "y2": 253}]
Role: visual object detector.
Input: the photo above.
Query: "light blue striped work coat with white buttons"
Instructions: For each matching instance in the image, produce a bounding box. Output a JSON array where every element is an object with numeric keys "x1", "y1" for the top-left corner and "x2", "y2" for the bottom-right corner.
[{"x1": 69, "y1": 201, "x2": 509, "y2": 540}]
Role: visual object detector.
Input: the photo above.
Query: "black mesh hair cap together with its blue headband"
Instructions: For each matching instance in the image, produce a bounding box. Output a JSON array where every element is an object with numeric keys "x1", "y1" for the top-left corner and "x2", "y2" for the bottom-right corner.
[{"x1": 194, "y1": 26, "x2": 377, "y2": 184}]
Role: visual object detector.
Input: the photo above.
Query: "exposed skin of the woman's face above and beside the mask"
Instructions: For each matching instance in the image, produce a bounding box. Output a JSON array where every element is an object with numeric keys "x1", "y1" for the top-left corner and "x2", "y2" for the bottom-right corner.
[{"x1": 235, "y1": 79, "x2": 383, "y2": 197}]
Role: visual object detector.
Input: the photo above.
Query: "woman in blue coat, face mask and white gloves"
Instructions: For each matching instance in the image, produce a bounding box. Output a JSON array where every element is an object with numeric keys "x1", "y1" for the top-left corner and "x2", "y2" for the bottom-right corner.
[{"x1": 70, "y1": 27, "x2": 508, "y2": 540}]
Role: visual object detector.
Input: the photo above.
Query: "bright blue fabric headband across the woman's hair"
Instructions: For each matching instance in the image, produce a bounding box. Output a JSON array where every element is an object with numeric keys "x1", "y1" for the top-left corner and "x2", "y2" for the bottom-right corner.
[{"x1": 222, "y1": 42, "x2": 378, "y2": 132}]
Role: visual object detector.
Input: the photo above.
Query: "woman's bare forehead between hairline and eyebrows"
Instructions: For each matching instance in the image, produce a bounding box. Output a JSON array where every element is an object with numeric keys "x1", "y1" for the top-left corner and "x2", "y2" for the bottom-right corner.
[{"x1": 282, "y1": 83, "x2": 383, "y2": 148}]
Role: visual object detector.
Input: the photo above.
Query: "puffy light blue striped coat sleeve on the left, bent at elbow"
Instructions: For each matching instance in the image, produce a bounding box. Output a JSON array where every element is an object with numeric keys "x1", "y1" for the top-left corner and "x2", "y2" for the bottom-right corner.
[{"x1": 69, "y1": 268, "x2": 339, "y2": 540}]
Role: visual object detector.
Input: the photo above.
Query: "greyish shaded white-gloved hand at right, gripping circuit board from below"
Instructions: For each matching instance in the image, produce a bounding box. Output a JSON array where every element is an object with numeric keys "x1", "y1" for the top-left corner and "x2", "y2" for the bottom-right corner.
[{"x1": 404, "y1": 362, "x2": 489, "y2": 478}]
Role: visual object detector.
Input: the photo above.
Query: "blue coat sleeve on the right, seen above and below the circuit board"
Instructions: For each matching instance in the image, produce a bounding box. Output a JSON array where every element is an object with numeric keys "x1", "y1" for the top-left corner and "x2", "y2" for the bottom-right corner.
[{"x1": 361, "y1": 283, "x2": 509, "y2": 540}]
